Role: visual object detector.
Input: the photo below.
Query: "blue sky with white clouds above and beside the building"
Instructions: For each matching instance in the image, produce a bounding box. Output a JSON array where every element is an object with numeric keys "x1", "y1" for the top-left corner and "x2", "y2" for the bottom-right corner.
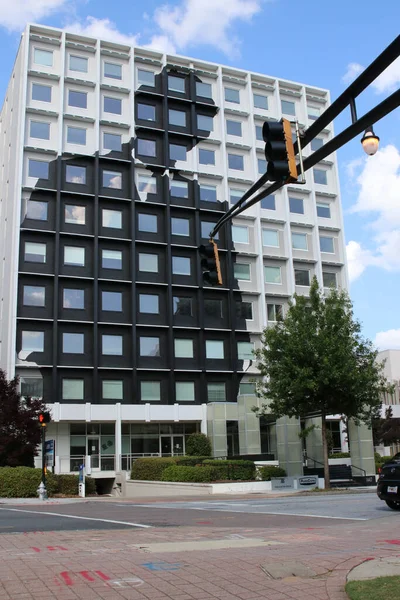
[{"x1": 0, "y1": 0, "x2": 400, "y2": 349}]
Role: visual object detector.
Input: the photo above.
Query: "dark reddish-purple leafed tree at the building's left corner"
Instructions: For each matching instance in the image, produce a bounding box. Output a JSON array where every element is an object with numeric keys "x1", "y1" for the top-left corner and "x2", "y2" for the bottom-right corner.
[{"x1": 0, "y1": 369, "x2": 45, "y2": 467}]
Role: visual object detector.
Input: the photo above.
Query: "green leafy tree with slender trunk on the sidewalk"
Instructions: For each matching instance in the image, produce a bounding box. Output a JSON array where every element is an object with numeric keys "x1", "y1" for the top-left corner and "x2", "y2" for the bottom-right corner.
[{"x1": 254, "y1": 277, "x2": 389, "y2": 487}]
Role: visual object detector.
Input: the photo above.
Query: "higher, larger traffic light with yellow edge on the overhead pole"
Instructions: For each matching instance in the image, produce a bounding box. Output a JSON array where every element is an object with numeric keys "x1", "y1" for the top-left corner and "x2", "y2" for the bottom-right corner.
[{"x1": 262, "y1": 119, "x2": 297, "y2": 183}]
